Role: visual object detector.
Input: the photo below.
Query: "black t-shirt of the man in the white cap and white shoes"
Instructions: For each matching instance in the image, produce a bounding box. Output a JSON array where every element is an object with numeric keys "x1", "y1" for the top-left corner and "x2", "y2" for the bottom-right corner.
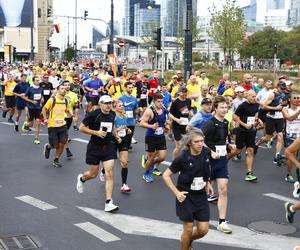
[{"x1": 82, "y1": 109, "x2": 115, "y2": 145}]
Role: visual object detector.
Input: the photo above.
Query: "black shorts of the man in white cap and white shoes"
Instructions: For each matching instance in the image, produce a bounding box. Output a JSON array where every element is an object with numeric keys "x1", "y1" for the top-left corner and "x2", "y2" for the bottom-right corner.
[{"x1": 85, "y1": 142, "x2": 117, "y2": 165}]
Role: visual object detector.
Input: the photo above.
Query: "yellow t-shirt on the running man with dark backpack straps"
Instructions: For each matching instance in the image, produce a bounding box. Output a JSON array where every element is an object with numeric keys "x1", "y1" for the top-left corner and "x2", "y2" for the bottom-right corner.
[{"x1": 45, "y1": 97, "x2": 70, "y2": 128}]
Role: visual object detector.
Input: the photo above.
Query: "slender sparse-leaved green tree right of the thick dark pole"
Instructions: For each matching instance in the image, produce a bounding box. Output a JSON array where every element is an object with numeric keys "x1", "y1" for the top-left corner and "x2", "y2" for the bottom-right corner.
[{"x1": 208, "y1": 0, "x2": 246, "y2": 64}]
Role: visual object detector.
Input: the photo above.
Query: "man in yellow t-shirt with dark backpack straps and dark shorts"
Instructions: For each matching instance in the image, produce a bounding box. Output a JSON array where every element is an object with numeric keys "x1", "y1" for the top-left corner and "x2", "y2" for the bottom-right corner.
[{"x1": 42, "y1": 84, "x2": 72, "y2": 168}]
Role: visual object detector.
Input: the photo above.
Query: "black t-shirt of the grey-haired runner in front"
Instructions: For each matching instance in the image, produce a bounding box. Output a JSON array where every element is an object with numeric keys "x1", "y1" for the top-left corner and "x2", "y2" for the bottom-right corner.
[{"x1": 169, "y1": 147, "x2": 210, "y2": 193}]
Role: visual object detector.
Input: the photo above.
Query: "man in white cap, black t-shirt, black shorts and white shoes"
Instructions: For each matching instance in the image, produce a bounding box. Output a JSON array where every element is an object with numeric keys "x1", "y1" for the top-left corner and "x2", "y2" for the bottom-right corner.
[{"x1": 76, "y1": 95, "x2": 122, "y2": 212}]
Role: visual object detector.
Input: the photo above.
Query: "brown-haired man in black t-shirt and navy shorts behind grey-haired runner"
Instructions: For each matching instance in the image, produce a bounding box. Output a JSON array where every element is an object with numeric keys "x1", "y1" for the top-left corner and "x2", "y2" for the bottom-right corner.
[{"x1": 202, "y1": 96, "x2": 232, "y2": 234}]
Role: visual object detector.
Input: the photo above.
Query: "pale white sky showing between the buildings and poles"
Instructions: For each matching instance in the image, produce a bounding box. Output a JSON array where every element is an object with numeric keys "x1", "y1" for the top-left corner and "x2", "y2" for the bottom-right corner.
[{"x1": 51, "y1": 0, "x2": 250, "y2": 49}]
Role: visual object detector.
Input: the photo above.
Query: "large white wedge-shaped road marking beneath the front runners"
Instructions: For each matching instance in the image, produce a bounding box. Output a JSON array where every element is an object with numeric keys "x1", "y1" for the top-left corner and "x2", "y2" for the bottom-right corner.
[{"x1": 77, "y1": 206, "x2": 299, "y2": 250}]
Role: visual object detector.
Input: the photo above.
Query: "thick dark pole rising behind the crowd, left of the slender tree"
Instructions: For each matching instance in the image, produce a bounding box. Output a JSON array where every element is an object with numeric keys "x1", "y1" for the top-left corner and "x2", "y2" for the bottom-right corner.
[{"x1": 184, "y1": 0, "x2": 193, "y2": 82}]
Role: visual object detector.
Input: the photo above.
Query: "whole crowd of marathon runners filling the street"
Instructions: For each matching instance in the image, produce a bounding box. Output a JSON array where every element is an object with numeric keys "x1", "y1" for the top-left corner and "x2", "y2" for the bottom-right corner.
[{"x1": 0, "y1": 62, "x2": 300, "y2": 249}]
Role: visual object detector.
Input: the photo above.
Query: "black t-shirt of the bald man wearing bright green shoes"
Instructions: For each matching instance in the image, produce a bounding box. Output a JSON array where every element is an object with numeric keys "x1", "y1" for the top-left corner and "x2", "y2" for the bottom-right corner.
[{"x1": 235, "y1": 101, "x2": 259, "y2": 130}]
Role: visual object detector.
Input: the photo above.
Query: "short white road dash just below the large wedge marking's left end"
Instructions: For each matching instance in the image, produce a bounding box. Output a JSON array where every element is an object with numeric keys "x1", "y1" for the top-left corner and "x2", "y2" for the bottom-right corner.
[{"x1": 74, "y1": 222, "x2": 121, "y2": 242}]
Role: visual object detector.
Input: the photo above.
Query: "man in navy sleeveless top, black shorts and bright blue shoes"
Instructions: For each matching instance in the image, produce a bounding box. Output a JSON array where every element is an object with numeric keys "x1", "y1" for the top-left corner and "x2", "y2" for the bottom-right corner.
[{"x1": 141, "y1": 93, "x2": 169, "y2": 182}]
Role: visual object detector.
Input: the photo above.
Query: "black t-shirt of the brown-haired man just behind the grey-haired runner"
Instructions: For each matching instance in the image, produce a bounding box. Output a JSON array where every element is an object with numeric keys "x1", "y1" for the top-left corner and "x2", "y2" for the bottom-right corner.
[{"x1": 202, "y1": 117, "x2": 228, "y2": 151}]
